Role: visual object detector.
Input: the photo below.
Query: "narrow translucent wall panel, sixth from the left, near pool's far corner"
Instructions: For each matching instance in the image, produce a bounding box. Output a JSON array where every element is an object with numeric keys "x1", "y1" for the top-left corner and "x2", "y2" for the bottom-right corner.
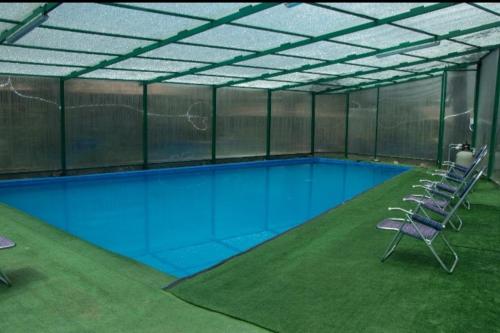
[{"x1": 314, "y1": 94, "x2": 346, "y2": 153}]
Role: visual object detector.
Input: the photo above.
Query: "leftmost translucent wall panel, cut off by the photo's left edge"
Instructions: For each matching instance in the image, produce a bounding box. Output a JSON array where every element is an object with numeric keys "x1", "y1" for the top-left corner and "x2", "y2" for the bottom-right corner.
[{"x1": 0, "y1": 76, "x2": 61, "y2": 173}]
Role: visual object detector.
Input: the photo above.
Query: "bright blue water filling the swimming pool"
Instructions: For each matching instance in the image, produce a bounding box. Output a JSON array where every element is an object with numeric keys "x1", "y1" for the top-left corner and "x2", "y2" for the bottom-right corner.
[{"x1": 0, "y1": 158, "x2": 408, "y2": 277}]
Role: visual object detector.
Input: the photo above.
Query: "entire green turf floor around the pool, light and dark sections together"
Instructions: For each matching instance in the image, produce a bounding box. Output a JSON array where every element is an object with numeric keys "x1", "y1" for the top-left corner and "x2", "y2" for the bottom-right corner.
[{"x1": 0, "y1": 171, "x2": 500, "y2": 332}]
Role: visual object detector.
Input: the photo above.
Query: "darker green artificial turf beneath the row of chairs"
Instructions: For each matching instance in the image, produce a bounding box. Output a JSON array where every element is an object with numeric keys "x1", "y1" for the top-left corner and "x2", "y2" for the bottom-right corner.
[{"x1": 169, "y1": 170, "x2": 500, "y2": 332}]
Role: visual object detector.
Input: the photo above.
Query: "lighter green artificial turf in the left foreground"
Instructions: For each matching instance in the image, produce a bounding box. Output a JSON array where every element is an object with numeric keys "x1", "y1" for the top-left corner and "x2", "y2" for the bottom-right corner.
[{"x1": 0, "y1": 205, "x2": 263, "y2": 333}]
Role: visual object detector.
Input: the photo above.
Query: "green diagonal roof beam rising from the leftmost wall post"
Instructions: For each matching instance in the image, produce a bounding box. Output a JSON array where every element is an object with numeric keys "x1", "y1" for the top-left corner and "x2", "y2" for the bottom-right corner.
[{"x1": 64, "y1": 2, "x2": 278, "y2": 80}]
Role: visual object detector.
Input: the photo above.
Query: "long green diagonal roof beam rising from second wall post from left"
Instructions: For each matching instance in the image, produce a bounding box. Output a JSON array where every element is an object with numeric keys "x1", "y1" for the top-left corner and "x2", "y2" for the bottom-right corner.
[{"x1": 147, "y1": 3, "x2": 457, "y2": 83}]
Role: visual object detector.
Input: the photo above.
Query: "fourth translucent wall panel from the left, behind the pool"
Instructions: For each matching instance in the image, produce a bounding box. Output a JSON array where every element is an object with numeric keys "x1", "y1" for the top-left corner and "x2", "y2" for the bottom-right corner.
[{"x1": 216, "y1": 88, "x2": 267, "y2": 158}]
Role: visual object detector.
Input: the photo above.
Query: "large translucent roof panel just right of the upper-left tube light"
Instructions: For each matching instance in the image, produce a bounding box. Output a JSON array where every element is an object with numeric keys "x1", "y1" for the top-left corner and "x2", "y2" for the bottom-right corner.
[{"x1": 47, "y1": 3, "x2": 205, "y2": 39}]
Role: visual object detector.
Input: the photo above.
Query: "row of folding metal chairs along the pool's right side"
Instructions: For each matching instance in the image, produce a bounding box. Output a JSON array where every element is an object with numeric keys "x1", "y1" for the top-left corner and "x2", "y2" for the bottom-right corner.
[{"x1": 377, "y1": 146, "x2": 488, "y2": 273}]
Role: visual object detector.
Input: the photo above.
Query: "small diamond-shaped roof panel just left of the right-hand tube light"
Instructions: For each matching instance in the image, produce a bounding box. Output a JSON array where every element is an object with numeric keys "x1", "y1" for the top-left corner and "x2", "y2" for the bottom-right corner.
[{"x1": 280, "y1": 41, "x2": 370, "y2": 60}]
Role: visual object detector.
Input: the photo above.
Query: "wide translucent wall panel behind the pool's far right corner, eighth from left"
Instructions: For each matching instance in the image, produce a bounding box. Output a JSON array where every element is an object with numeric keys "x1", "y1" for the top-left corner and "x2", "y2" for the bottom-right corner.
[{"x1": 377, "y1": 77, "x2": 441, "y2": 160}]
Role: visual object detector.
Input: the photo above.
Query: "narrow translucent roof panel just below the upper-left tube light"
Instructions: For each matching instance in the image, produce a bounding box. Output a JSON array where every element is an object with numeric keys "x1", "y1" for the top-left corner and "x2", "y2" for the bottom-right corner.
[{"x1": 16, "y1": 28, "x2": 150, "y2": 53}]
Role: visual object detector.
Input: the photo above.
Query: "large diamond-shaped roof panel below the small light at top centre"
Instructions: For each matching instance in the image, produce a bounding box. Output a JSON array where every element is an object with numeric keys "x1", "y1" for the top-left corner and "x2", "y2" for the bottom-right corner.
[{"x1": 235, "y1": 3, "x2": 370, "y2": 36}]
